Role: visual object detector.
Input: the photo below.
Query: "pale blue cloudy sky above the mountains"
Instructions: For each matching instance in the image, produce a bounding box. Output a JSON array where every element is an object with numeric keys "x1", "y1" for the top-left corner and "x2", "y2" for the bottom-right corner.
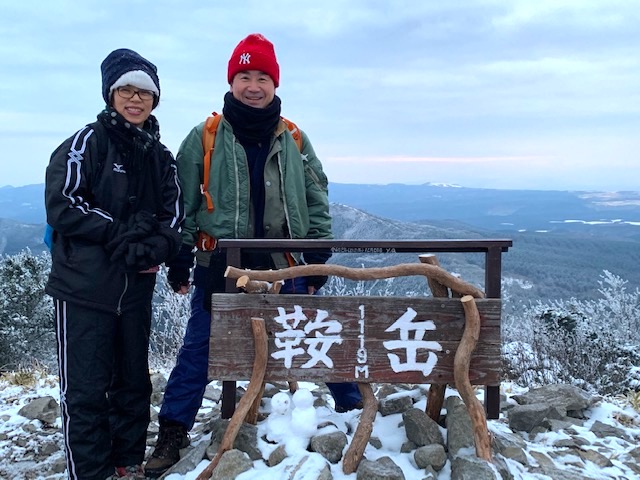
[{"x1": 0, "y1": 0, "x2": 640, "y2": 190}]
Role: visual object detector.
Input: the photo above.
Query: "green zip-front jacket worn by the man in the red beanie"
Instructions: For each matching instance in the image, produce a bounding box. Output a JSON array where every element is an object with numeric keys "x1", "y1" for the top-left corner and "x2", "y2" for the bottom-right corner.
[{"x1": 176, "y1": 118, "x2": 333, "y2": 268}]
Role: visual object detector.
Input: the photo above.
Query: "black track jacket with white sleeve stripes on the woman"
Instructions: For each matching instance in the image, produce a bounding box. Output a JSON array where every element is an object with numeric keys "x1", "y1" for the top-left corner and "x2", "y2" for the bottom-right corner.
[{"x1": 45, "y1": 122, "x2": 184, "y2": 313}]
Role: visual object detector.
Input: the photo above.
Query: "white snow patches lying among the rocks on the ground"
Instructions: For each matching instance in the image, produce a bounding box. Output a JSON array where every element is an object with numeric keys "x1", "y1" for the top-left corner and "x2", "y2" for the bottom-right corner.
[{"x1": 0, "y1": 375, "x2": 640, "y2": 480}]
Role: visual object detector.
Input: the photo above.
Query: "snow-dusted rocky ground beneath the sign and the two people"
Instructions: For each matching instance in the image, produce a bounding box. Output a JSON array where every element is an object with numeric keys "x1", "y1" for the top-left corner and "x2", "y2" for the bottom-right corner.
[{"x1": 0, "y1": 374, "x2": 640, "y2": 480}]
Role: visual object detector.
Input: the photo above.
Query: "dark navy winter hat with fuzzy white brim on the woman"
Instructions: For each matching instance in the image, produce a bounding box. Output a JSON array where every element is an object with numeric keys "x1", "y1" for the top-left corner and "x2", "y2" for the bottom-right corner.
[{"x1": 100, "y1": 48, "x2": 160, "y2": 108}]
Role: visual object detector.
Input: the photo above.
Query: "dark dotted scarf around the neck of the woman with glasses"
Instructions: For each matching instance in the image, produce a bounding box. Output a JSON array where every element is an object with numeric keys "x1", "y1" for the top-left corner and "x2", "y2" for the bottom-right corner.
[{"x1": 98, "y1": 106, "x2": 160, "y2": 172}]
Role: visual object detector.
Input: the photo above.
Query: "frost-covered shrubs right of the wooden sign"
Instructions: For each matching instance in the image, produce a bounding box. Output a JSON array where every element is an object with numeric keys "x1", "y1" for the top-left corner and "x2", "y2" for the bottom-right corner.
[{"x1": 503, "y1": 271, "x2": 640, "y2": 394}]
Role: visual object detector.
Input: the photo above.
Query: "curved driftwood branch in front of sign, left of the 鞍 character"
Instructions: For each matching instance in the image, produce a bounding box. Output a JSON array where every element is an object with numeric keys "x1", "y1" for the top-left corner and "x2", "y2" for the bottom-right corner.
[{"x1": 196, "y1": 318, "x2": 268, "y2": 480}]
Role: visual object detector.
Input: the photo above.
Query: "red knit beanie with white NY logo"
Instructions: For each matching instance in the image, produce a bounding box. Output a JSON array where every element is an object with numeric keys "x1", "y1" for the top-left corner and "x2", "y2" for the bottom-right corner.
[{"x1": 227, "y1": 33, "x2": 280, "y2": 87}]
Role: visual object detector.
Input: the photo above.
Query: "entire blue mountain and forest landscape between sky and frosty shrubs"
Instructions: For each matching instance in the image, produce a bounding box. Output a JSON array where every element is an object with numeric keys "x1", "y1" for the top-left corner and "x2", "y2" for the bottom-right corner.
[{"x1": 0, "y1": 184, "x2": 640, "y2": 300}]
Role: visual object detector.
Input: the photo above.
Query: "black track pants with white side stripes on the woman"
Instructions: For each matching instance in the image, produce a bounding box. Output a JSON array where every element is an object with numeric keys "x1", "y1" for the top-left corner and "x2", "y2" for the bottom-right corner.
[{"x1": 55, "y1": 300, "x2": 151, "y2": 480}]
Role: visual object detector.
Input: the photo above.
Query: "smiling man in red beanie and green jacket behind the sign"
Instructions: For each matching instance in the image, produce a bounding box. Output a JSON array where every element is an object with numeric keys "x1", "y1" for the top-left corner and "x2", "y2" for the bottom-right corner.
[{"x1": 145, "y1": 34, "x2": 362, "y2": 477}]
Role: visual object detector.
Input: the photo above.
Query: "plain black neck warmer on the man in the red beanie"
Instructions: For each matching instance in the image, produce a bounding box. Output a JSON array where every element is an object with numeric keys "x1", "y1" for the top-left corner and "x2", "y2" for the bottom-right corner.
[{"x1": 222, "y1": 92, "x2": 280, "y2": 143}]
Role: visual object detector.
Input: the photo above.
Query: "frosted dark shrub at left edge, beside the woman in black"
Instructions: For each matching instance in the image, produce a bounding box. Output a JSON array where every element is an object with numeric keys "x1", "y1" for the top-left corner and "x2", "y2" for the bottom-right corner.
[{"x1": 0, "y1": 249, "x2": 55, "y2": 369}]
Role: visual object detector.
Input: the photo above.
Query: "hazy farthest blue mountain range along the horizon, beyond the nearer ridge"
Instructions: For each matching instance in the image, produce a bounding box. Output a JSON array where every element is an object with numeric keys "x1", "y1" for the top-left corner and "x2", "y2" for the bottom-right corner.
[{"x1": 5, "y1": 183, "x2": 640, "y2": 238}]
